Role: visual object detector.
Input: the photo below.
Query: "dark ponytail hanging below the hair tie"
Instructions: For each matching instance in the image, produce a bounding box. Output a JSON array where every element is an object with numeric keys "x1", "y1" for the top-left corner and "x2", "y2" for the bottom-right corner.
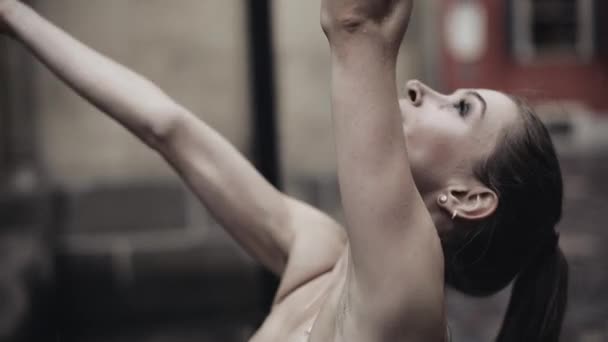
[{"x1": 496, "y1": 239, "x2": 568, "y2": 342}]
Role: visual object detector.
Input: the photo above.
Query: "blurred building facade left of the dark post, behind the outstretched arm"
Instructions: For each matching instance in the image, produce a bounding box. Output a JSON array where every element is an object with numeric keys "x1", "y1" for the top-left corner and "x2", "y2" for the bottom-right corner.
[{"x1": 0, "y1": 0, "x2": 261, "y2": 342}]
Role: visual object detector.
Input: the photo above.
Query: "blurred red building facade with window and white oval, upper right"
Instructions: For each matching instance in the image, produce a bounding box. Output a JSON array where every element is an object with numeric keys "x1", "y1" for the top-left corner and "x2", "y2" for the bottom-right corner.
[{"x1": 440, "y1": 0, "x2": 608, "y2": 114}]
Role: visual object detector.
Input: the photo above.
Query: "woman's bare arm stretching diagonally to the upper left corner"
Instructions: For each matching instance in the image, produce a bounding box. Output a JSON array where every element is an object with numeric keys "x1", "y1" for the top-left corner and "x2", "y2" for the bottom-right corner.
[{"x1": 0, "y1": 0, "x2": 341, "y2": 274}]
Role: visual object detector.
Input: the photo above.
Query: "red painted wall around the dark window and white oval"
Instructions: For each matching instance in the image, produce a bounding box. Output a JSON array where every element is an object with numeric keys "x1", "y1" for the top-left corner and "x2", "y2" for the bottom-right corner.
[{"x1": 440, "y1": 0, "x2": 608, "y2": 114}]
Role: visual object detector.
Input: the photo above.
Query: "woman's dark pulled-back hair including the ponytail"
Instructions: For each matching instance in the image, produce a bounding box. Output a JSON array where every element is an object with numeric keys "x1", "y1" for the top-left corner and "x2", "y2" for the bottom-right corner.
[{"x1": 443, "y1": 97, "x2": 568, "y2": 342}]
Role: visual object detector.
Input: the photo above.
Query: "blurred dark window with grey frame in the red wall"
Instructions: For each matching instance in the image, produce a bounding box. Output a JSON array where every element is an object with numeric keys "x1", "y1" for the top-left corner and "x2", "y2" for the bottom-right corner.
[{"x1": 510, "y1": 0, "x2": 597, "y2": 62}]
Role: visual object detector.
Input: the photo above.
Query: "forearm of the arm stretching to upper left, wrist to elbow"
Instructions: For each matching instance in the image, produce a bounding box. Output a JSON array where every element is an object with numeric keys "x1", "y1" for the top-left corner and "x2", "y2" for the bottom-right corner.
[{"x1": 5, "y1": 3, "x2": 181, "y2": 143}]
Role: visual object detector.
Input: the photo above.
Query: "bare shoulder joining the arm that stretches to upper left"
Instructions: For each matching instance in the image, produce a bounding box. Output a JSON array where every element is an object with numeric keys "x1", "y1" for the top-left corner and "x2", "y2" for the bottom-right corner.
[{"x1": 275, "y1": 197, "x2": 347, "y2": 303}]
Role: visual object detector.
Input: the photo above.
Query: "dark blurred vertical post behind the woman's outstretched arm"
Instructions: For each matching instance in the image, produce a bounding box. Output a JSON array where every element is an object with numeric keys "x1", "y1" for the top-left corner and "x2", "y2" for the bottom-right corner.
[{"x1": 247, "y1": 0, "x2": 281, "y2": 310}]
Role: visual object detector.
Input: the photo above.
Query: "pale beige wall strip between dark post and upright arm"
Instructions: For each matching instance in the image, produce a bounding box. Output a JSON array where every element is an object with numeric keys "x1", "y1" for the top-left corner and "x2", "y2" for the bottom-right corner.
[{"x1": 273, "y1": 0, "x2": 335, "y2": 177}]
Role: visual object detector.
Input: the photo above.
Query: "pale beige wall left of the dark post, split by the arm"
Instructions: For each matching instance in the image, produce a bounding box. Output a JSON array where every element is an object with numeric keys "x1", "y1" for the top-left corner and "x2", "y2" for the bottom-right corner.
[{"x1": 35, "y1": 0, "x2": 249, "y2": 184}]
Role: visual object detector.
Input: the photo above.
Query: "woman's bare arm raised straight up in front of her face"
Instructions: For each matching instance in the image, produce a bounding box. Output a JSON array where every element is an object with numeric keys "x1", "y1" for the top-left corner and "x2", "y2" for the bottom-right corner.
[{"x1": 321, "y1": 0, "x2": 443, "y2": 341}]
